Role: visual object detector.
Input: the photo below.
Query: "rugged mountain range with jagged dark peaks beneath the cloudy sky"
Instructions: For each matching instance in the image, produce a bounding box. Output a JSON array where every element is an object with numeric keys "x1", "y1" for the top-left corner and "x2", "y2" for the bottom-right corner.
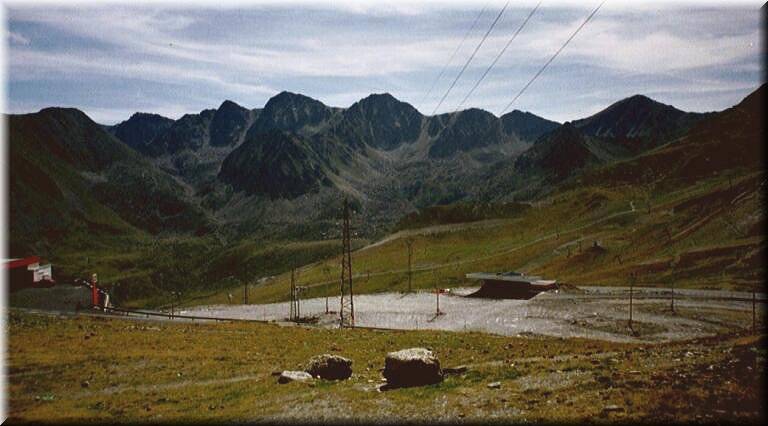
[{"x1": 9, "y1": 87, "x2": 763, "y2": 253}]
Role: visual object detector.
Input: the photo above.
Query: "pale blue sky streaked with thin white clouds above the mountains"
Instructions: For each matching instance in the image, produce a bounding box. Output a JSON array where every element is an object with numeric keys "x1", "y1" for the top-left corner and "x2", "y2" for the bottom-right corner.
[{"x1": 4, "y1": 0, "x2": 763, "y2": 124}]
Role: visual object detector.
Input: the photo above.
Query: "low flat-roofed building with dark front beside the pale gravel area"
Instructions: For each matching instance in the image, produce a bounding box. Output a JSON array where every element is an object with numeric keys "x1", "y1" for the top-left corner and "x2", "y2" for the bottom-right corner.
[{"x1": 466, "y1": 271, "x2": 557, "y2": 299}]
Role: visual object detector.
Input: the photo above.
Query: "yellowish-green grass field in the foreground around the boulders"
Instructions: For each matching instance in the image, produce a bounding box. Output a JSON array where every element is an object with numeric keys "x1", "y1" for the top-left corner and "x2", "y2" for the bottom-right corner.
[{"x1": 7, "y1": 310, "x2": 765, "y2": 423}]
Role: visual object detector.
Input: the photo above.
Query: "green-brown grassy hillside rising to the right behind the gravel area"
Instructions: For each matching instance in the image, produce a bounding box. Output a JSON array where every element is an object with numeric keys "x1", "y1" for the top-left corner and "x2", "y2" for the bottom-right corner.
[{"x1": 195, "y1": 88, "x2": 766, "y2": 303}]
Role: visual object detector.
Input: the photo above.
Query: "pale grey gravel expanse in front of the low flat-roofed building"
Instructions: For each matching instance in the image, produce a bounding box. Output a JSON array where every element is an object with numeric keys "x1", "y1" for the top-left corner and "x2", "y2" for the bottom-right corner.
[{"x1": 184, "y1": 287, "x2": 765, "y2": 342}]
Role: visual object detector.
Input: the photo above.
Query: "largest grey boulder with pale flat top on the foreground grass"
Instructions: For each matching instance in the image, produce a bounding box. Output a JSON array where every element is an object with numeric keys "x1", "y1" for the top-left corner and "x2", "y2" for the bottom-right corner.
[{"x1": 383, "y1": 348, "x2": 443, "y2": 387}]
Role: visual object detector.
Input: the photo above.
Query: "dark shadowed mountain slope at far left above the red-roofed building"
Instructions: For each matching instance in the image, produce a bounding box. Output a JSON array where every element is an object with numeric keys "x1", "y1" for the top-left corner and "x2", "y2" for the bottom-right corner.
[{"x1": 8, "y1": 108, "x2": 210, "y2": 254}]
